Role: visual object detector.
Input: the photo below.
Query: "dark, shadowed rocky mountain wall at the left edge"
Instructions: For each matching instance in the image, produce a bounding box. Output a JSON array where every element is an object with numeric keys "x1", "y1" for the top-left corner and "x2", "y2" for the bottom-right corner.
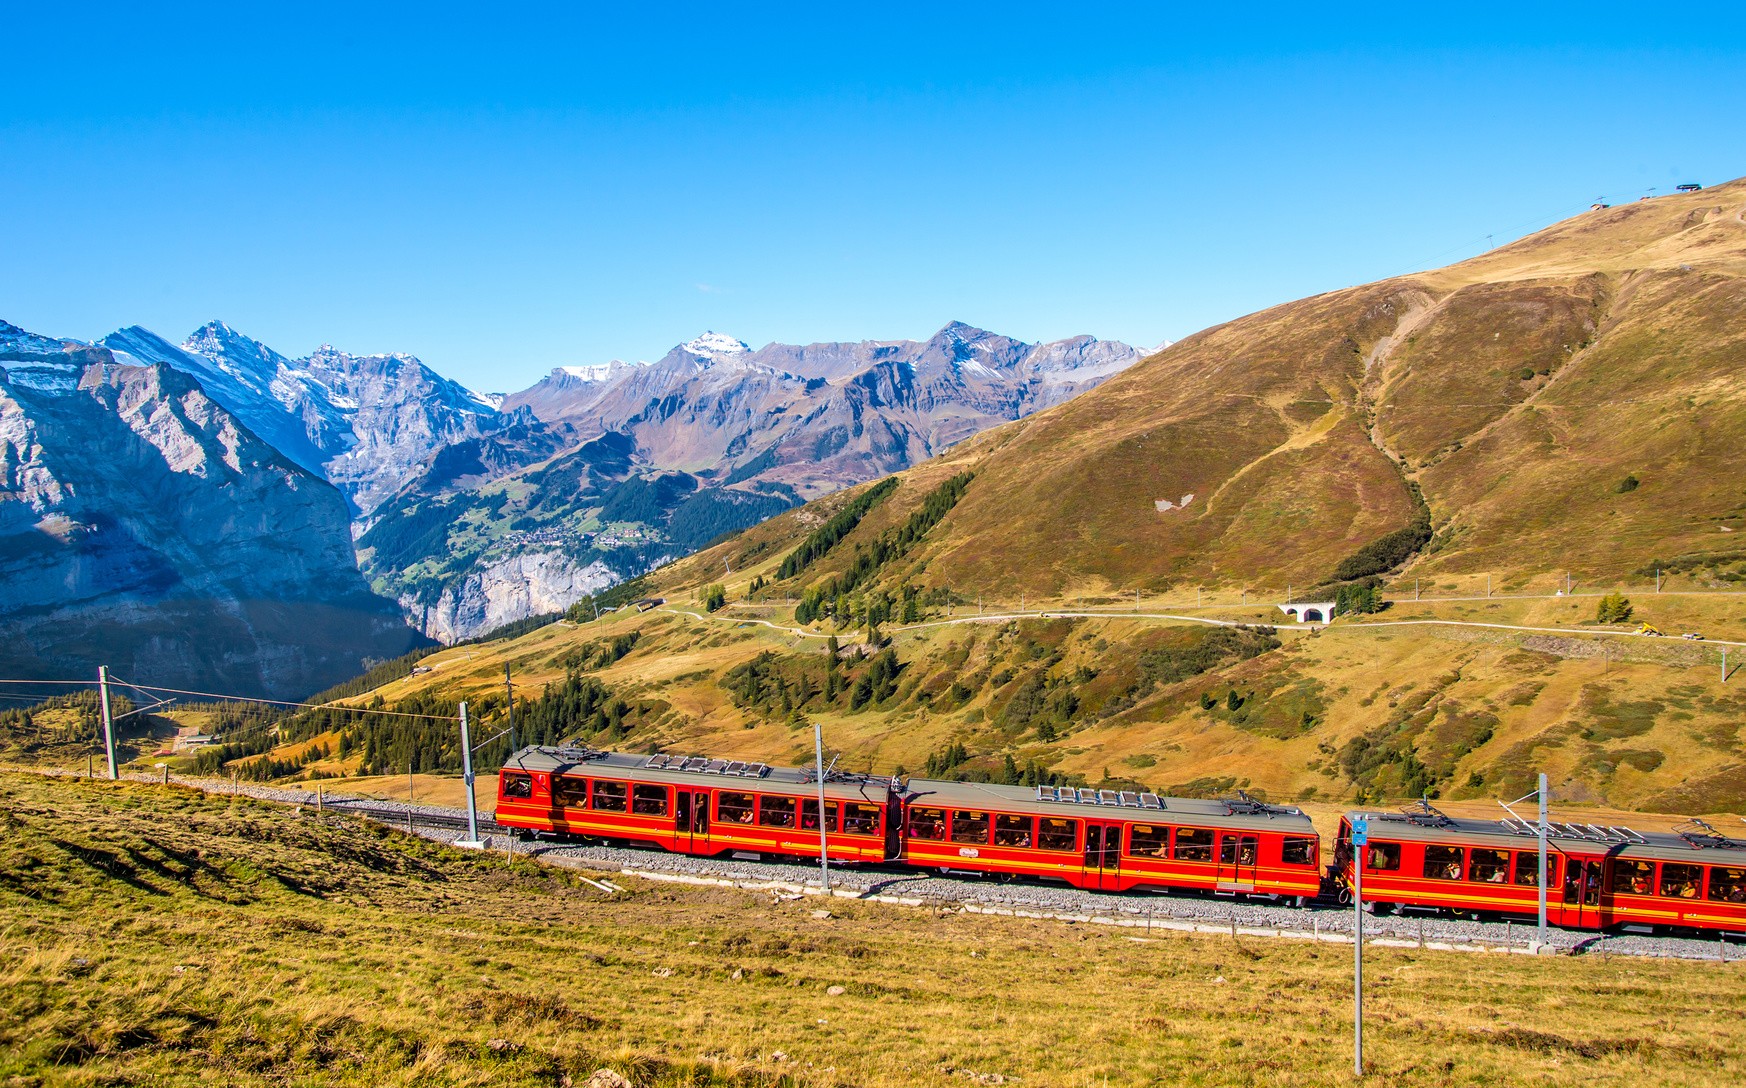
[{"x1": 0, "y1": 323, "x2": 416, "y2": 697}]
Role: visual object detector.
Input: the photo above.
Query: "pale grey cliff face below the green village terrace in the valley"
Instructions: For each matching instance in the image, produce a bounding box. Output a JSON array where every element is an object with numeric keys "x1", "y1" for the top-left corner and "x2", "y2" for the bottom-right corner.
[{"x1": 400, "y1": 552, "x2": 625, "y2": 643}]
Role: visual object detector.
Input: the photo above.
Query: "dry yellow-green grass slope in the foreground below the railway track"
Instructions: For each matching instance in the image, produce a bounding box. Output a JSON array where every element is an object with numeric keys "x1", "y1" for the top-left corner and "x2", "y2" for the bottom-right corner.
[{"x1": 0, "y1": 775, "x2": 1746, "y2": 1088}]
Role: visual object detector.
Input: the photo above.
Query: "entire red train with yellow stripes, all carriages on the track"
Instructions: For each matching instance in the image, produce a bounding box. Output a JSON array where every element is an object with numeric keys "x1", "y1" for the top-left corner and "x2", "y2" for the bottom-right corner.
[{"x1": 496, "y1": 746, "x2": 1746, "y2": 934}]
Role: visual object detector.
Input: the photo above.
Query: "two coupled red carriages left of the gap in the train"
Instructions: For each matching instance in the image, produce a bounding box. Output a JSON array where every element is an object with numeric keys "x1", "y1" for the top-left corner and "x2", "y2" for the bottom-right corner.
[{"x1": 496, "y1": 747, "x2": 1322, "y2": 901}]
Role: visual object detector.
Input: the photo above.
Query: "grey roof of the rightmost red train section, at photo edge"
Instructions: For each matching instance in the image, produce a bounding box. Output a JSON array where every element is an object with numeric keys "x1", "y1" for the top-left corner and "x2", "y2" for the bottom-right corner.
[{"x1": 1344, "y1": 803, "x2": 1746, "y2": 866}]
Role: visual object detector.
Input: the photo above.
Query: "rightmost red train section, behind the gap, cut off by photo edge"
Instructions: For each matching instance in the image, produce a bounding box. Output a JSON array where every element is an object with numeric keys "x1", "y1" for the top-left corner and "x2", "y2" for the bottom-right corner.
[{"x1": 1334, "y1": 803, "x2": 1746, "y2": 933}]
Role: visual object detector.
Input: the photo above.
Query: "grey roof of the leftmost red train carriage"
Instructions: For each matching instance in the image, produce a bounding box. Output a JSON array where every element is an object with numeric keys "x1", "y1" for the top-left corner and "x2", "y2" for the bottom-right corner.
[{"x1": 503, "y1": 744, "x2": 892, "y2": 805}]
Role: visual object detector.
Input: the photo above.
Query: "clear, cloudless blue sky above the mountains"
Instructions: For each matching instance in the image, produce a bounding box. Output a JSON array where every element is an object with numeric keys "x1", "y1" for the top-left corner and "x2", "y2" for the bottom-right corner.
[{"x1": 0, "y1": 2, "x2": 1746, "y2": 391}]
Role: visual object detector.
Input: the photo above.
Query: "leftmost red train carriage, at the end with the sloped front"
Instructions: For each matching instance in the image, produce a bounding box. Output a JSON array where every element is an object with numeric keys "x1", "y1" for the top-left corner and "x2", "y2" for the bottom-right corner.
[{"x1": 496, "y1": 746, "x2": 897, "y2": 861}]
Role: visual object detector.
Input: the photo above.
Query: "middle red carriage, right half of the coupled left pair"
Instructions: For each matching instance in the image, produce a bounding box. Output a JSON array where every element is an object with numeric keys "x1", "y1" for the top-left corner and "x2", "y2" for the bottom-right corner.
[{"x1": 903, "y1": 779, "x2": 1320, "y2": 899}]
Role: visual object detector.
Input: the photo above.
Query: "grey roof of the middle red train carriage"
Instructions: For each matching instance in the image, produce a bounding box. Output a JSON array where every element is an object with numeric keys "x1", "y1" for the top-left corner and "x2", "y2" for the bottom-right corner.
[{"x1": 904, "y1": 779, "x2": 1315, "y2": 835}]
